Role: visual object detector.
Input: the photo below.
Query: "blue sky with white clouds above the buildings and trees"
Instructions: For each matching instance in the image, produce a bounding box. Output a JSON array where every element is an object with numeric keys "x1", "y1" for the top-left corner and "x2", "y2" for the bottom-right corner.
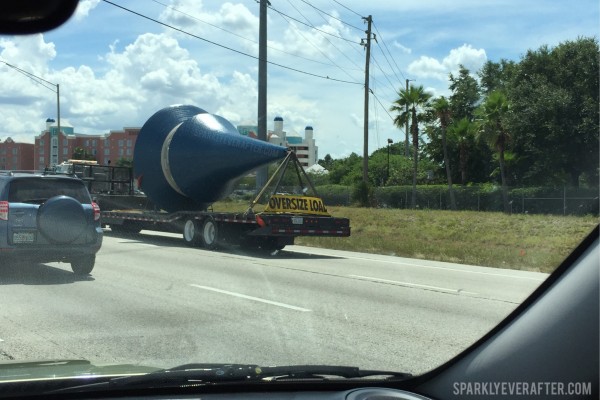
[{"x1": 0, "y1": 0, "x2": 600, "y2": 158}]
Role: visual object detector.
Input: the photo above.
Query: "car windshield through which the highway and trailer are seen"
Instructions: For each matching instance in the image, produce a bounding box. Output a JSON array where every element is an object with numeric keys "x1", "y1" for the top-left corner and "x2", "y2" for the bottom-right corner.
[{"x1": 0, "y1": 0, "x2": 600, "y2": 397}]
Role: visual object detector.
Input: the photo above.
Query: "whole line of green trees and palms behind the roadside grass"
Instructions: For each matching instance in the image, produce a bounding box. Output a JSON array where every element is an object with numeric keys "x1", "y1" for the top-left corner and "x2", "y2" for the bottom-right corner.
[{"x1": 319, "y1": 37, "x2": 600, "y2": 210}]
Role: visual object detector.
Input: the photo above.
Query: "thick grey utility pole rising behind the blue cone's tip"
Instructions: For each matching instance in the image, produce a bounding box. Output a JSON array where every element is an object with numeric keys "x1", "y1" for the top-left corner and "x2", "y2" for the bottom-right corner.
[{"x1": 256, "y1": 0, "x2": 271, "y2": 190}]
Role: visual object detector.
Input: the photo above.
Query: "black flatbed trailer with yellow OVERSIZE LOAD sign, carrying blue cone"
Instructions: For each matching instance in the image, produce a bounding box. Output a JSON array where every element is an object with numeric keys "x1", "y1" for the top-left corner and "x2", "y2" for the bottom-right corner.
[{"x1": 62, "y1": 152, "x2": 350, "y2": 250}]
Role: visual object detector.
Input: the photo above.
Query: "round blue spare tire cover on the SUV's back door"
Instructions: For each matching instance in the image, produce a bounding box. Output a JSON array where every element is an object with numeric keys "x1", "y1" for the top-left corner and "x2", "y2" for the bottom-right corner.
[{"x1": 37, "y1": 196, "x2": 87, "y2": 244}]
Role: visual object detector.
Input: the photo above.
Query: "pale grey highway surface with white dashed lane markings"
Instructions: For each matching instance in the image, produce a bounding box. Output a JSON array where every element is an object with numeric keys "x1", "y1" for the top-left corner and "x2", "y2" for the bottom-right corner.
[{"x1": 0, "y1": 231, "x2": 547, "y2": 373}]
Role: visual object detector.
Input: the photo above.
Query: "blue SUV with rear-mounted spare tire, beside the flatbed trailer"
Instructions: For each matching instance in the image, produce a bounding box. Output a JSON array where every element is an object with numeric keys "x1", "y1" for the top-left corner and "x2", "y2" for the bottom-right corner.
[{"x1": 0, "y1": 172, "x2": 102, "y2": 275}]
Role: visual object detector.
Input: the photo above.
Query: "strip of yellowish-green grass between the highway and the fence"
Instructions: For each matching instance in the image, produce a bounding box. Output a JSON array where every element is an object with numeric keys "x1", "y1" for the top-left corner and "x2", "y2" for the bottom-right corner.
[{"x1": 215, "y1": 202, "x2": 598, "y2": 273}]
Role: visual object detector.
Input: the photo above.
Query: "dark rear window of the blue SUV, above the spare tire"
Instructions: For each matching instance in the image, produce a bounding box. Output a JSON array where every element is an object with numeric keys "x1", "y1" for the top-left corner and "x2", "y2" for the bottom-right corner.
[{"x1": 8, "y1": 178, "x2": 91, "y2": 204}]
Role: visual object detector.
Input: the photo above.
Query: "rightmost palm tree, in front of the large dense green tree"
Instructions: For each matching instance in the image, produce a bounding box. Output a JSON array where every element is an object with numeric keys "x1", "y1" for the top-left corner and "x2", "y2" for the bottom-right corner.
[{"x1": 476, "y1": 90, "x2": 511, "y2": 213}]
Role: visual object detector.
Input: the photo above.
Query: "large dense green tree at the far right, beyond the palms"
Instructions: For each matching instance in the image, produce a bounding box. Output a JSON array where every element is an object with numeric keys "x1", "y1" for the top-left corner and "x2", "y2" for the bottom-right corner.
[{"x1": 507, "y1": 38, "x2": 600, "y2": 186}]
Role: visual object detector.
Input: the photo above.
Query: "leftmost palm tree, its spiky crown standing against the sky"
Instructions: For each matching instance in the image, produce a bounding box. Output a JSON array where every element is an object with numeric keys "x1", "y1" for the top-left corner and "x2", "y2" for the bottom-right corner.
[{"x1": 390, "y1": 85, "x2": 431, "y2": 208}]
